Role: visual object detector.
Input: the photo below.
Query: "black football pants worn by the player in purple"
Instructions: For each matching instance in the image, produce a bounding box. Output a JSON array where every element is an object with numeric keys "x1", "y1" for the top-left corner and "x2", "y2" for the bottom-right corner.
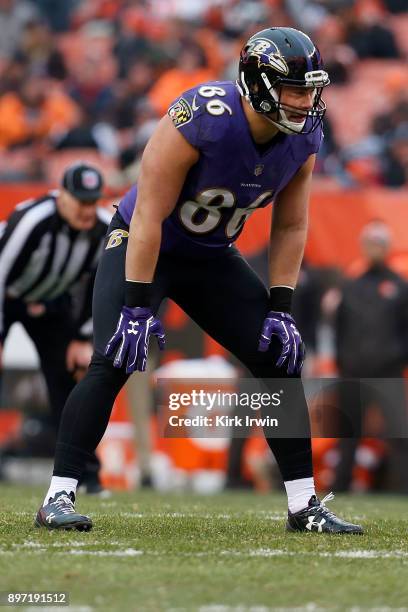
[{"x1": 54, "y1": 213, "x2": 312, "y2": 480}]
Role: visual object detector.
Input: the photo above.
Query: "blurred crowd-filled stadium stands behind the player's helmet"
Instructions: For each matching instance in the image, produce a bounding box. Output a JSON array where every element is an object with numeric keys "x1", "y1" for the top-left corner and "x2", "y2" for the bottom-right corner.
[{"x1": 0, "y1": 0, "x2": 408, "y2": 187}]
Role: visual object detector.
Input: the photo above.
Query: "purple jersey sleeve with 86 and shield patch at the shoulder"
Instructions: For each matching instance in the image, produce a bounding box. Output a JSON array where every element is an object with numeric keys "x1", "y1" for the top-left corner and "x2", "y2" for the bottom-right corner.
[{"x1": 167, "y1": 82, "x2": 233, "y2": 150}]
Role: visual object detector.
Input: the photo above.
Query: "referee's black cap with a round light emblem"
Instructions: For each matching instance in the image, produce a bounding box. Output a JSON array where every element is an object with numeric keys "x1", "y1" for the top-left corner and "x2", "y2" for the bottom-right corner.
[{"x1": 62, "y1": 162, "x2": 103, "y2": 202}]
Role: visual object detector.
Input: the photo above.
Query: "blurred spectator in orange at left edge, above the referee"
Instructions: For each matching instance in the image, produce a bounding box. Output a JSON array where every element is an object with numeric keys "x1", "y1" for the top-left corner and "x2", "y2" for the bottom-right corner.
[{"x1": 0, "y1": 75, "x2": 80, "y2": 148}]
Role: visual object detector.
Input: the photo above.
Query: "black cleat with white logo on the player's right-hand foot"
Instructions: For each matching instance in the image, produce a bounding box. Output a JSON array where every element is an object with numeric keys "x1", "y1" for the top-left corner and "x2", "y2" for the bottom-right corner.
[{"x1": 286, "y1": 493, "x2": 364, "y2": 534}]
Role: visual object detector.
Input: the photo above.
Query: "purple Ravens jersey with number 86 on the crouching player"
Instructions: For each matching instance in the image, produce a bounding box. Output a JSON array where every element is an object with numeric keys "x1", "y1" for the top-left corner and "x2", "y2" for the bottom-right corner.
[{"x1": 119, "y1": 81, "x2": 322, "y2": 251}]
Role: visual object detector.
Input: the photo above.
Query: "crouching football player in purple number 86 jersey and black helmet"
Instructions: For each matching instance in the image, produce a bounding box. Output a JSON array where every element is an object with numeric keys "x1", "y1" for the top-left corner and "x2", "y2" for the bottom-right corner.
[{"x1": 36, "y1": 27, "x2": 362, "y2": 533}]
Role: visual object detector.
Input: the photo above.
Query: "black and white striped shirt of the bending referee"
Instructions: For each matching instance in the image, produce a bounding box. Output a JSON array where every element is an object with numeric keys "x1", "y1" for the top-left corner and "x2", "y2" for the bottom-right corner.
[{"x1": 0, "y1": 191, "x2": 111, "y2": 338}]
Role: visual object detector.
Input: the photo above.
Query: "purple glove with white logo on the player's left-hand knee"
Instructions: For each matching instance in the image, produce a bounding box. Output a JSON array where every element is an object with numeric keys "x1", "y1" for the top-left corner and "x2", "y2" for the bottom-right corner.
[{"x1": 105, "y1": 306, "x2": 165, "y2": 374}]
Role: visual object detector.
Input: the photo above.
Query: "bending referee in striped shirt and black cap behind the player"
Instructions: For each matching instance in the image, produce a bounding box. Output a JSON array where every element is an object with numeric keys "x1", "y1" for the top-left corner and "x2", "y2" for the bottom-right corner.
[{"x1": 0, "y1": 162, "x2": 111, "y2": 493}]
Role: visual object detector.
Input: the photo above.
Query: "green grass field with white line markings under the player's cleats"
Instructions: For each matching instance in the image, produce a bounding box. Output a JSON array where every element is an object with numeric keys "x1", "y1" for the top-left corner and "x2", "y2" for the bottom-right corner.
[{"x1": 0, "y1": 485, "x2": 408, "y2": 612}]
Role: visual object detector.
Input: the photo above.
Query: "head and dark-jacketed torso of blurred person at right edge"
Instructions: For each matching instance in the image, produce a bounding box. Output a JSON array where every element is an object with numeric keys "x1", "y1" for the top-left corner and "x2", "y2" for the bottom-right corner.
[{"x1": 336, "y1": 221, "x2": 408, "y2": 377}]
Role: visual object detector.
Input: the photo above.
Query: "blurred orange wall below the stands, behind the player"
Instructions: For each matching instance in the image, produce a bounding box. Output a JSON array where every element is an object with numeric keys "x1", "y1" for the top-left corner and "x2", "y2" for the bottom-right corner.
[{"x1": 0, "y1": 183, "x2": 408, "y2": 270}]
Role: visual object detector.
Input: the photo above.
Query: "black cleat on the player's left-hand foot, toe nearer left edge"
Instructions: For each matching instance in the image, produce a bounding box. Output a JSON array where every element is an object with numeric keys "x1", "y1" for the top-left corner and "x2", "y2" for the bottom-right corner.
[{"x1": 35, "y1": 491, "x2": 92, "y2": 531}]
